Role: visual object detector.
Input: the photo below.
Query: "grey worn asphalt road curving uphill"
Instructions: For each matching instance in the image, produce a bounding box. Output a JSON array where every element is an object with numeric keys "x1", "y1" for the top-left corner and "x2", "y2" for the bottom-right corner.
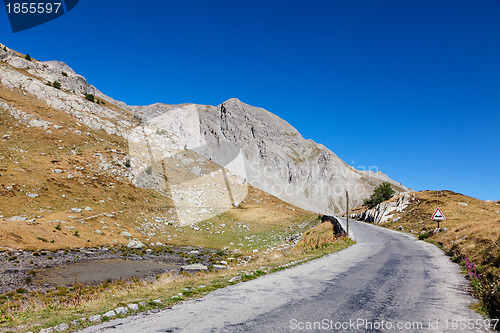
[{"x1": 82, "y1": 222, "x2": 484, "y2": 333}]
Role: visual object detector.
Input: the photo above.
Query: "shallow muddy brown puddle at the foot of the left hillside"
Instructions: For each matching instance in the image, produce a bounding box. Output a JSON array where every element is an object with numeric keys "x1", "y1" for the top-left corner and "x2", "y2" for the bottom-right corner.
[{"x1": 34, "y1": 259, "x2": 181, "y2": 285}]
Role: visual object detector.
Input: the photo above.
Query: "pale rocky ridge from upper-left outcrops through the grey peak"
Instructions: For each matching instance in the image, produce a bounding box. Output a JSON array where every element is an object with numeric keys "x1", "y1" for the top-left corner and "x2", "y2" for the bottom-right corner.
[{"x1": 0, "y1": 42, "x2": 409, "y2": 214}]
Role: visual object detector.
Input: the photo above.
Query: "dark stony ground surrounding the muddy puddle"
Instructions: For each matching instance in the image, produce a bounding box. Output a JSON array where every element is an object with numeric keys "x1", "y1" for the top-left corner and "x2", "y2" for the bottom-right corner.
[{"x1": 0, "y1": 245, "x2": 227, "y2": 293}]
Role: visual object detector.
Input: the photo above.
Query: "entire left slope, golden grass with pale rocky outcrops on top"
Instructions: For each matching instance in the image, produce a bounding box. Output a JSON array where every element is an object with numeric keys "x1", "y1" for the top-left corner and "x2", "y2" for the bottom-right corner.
[{"x1": 0, "y1": 47, "x2": 317, "y2": 250}]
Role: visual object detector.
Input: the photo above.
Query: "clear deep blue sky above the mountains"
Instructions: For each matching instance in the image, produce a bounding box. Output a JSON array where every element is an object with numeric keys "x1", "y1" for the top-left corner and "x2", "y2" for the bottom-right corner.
[{"x1": 0, "y1": 0, "x2": 500, "y2": 200}]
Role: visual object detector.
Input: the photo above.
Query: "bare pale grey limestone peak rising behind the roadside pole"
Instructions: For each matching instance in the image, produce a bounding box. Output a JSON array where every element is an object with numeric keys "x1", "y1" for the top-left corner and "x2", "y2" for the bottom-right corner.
[{"x1": 137, "y1": 98, "x2": 409, "y2": 214}]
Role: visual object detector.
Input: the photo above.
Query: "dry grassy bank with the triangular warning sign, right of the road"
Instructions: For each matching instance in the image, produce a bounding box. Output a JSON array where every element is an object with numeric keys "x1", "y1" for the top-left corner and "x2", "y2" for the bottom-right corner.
[{"x1": 358, "y1": 191, "x2": 500, "y2": 318}]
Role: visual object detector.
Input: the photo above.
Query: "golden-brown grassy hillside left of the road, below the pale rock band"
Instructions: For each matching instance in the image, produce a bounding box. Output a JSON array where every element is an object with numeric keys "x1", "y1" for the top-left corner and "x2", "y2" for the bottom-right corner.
[{"x1": 0, "y1": 86, "x2": 316, "y2": 254}]
